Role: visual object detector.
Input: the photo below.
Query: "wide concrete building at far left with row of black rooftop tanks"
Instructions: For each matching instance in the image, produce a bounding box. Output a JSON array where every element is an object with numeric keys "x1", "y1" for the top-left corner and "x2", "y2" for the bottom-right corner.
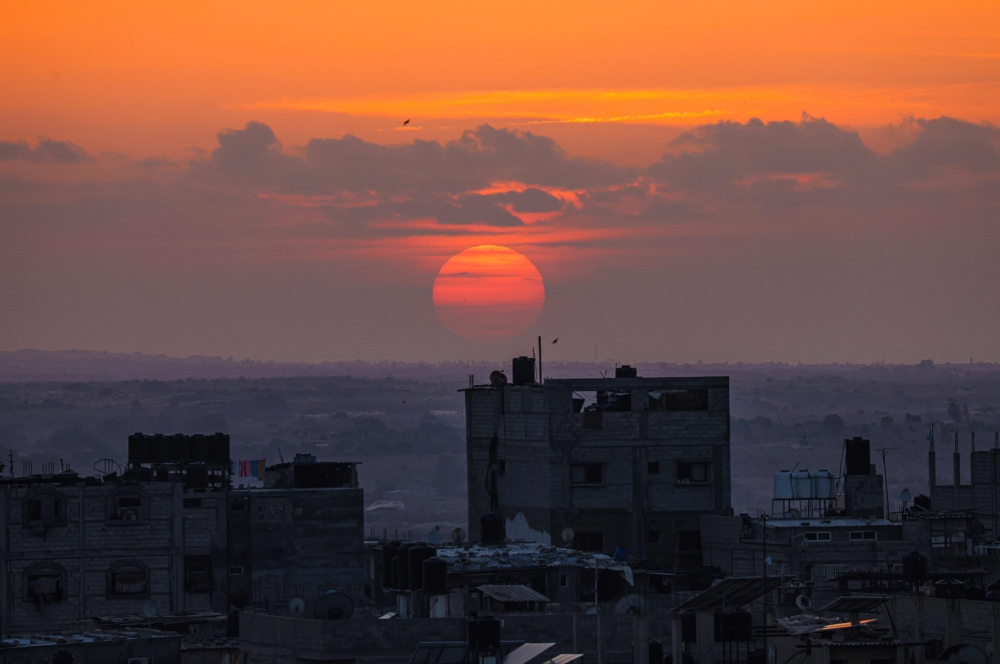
[{"x1": 0, "y1": 434, "x2": 364, "y2": 634}]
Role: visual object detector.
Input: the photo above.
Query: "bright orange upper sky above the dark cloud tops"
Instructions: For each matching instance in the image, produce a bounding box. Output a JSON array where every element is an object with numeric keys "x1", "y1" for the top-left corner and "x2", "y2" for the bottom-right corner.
[{"x1": 0, "y1": 0, "x2": 1000, "y2": 164}]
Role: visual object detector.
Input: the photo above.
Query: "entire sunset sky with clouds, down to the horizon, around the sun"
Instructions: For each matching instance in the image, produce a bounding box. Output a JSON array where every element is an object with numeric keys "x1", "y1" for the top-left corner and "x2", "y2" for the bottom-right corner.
[{"x1": 0, "y1": 0, "x2": 1000, "y2": 363}]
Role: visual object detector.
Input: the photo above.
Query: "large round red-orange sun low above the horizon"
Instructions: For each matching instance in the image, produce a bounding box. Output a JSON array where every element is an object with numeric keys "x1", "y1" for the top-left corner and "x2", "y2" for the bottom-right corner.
[{"x1": 434, "y1": 244, "x2": 545, "y2": 342}]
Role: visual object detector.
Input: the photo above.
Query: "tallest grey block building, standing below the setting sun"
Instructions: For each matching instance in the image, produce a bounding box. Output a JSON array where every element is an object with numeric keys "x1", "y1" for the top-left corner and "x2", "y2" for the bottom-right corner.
[{"x1": 465, "y1": 358, "x2": 731, "y2": 569}]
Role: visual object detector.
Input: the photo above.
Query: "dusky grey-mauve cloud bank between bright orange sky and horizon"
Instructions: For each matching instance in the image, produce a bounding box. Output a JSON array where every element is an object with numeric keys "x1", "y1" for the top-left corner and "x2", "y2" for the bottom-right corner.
[{"x1": 0, "y1": 118, "x2": 1000, "y2": 361}]
